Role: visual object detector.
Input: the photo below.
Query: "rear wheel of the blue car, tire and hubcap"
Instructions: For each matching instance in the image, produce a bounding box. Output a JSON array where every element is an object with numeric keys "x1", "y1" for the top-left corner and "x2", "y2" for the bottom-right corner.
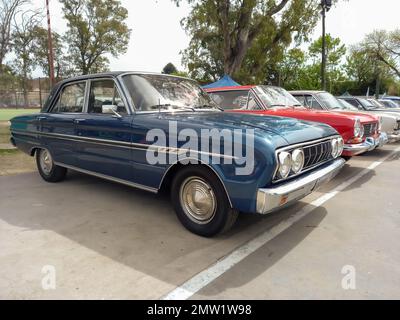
[{"x1": 36, "y1": 149, "x2": 67, "y2": 182}]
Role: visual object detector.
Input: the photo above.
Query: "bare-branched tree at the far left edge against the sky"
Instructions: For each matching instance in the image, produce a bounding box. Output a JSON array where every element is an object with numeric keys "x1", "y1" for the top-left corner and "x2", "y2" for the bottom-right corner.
[{"x1": 0, "y1": 0, "x2": 30, "y2": 74}]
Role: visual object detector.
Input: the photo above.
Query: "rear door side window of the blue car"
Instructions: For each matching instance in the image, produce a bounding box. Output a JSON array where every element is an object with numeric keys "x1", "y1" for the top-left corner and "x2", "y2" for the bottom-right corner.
[{"x1": 51, "y1": 82, "x2": 86, "y2": 113}]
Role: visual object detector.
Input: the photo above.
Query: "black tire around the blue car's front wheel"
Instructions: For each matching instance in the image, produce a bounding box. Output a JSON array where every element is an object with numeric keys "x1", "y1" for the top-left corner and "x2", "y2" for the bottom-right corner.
[{"x1": 171, "y1": 166, "x2": 238, "y2": 237}]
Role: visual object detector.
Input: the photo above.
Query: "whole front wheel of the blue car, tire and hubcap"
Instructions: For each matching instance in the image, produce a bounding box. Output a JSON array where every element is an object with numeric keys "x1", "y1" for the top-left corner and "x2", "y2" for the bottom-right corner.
[{"x1": 171, "y1": 166, "x2": 238, "y2": 237}]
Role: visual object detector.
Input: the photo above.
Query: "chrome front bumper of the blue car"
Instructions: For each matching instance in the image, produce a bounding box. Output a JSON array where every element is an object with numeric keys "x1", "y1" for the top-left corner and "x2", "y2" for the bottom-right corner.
[{"x1": 257, "y1": 159, "x2": 345, "y2": 214}]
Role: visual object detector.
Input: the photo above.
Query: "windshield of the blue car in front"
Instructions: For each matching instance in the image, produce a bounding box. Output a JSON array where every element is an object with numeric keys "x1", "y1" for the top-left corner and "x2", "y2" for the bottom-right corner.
[{"x1": 123, "y1": 74, "x2": 219, "y2": 111}]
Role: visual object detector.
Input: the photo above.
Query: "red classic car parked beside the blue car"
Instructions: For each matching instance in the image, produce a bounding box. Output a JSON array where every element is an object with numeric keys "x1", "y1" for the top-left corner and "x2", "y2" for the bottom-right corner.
[{"x1": 206, "y1": 85, "x2": 385, "y2": 157}]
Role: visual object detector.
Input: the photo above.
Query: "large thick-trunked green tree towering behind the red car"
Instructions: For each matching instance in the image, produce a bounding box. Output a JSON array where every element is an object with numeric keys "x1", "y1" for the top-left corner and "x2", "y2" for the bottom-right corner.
[{"x1": 173, "y1": 0, "x2": 319, "y2": 80}]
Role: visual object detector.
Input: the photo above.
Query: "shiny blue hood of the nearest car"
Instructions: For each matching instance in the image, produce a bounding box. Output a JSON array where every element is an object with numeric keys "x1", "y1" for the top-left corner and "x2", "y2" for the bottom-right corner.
[{"x1": 137, "y1": 112, "x2": 338, "y2": 147}]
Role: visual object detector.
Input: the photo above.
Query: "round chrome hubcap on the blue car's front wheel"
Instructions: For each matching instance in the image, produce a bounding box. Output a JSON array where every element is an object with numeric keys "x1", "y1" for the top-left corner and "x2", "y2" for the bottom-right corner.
[{"x1": 180, "y1": 177, "x2": 217, "y2": 224}]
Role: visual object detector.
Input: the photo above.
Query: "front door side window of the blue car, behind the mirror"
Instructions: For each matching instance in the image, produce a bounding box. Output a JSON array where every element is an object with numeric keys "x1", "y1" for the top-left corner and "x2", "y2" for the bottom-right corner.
[{"x1": 88, "y1": 80, "x2": 127, "y2": 114}]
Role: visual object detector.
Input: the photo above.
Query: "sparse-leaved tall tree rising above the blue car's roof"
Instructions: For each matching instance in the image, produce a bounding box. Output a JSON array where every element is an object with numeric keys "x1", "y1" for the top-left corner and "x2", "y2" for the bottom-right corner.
[{"x1": 60, "y1": 0, "x2": 131, "y2": 74}]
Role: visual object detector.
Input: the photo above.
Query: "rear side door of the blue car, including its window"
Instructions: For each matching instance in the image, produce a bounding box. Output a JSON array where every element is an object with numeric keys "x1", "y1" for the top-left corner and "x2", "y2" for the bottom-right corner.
[{"x1": 38, "y1": 81, "x2": 87, "y2": 166}]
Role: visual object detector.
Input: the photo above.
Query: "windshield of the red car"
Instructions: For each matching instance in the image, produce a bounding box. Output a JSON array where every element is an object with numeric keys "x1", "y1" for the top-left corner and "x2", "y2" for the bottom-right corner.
[{"x1": 254, "y1": 86, "x2": 302, "y2": 108}]
